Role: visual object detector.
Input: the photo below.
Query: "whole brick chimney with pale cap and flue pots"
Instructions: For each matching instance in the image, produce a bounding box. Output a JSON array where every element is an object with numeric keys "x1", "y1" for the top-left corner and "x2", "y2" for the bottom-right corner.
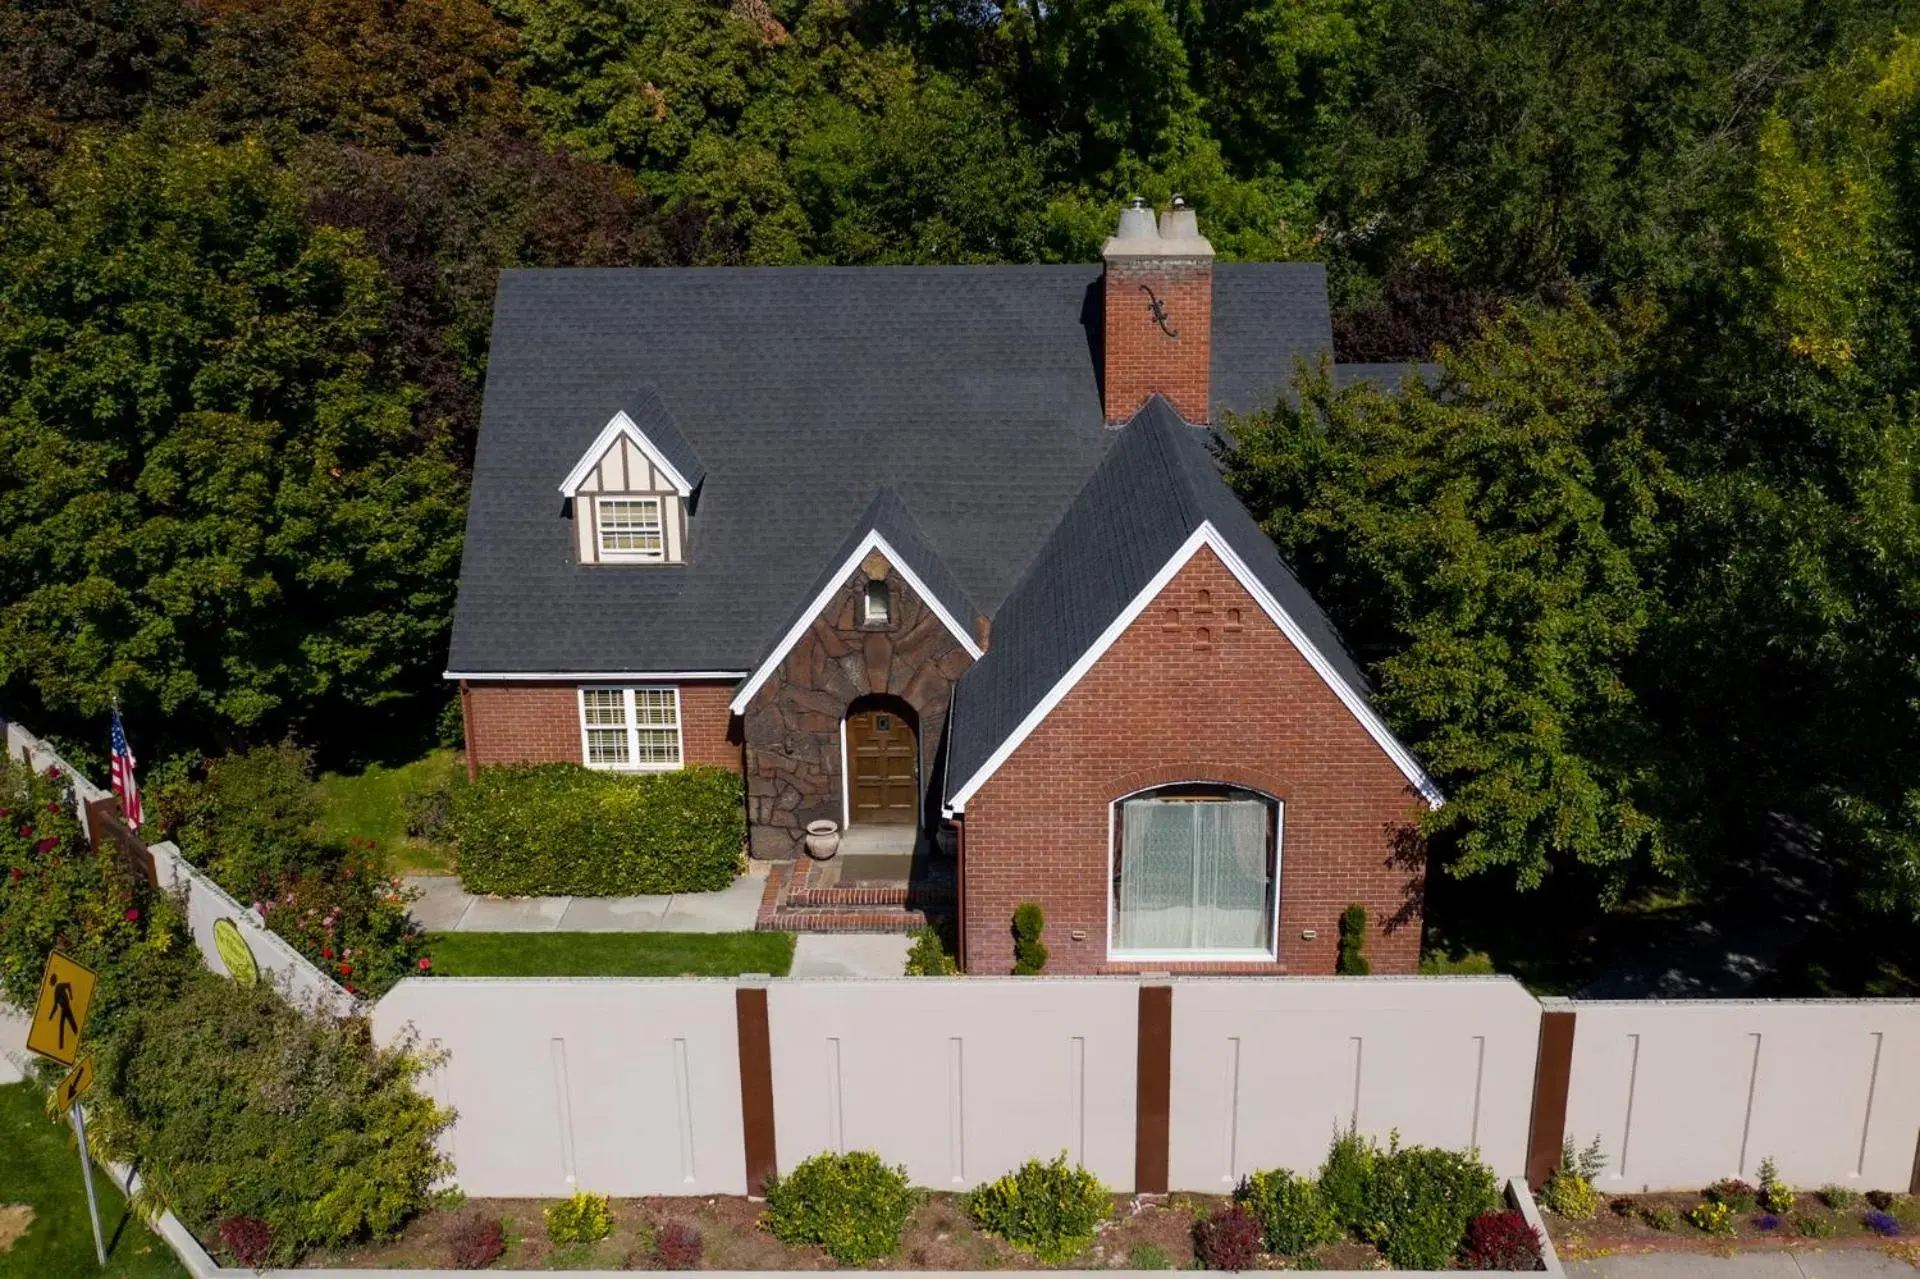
[{"x1": 1100, "y1": 196, "x2": 1213, "y2": 426}]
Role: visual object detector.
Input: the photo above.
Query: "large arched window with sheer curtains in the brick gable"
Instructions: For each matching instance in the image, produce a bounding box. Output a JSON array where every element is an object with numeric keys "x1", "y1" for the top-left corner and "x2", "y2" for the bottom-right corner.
[{"x1": 1110, "y1": 785, "x2": 1281, "y2": 958}]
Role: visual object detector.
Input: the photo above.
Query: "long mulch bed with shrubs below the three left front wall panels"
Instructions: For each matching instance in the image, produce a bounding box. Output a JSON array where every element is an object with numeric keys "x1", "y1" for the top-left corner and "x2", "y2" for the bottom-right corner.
[{"x1": 301, "y1": 1193, "x2": 1413, "y2": 1269}]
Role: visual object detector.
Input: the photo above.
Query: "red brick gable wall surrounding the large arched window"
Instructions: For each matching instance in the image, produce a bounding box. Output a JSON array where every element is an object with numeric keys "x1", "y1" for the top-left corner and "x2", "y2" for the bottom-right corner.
[{"x1": 964, "y1": 547, "x2": 1425, "y2": 974}]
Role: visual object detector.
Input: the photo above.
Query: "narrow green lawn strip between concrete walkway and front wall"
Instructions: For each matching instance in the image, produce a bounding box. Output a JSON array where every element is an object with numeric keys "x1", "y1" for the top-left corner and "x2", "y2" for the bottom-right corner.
[{"x1": 428, "y1": 933, "x2": 793, "y2": 977}]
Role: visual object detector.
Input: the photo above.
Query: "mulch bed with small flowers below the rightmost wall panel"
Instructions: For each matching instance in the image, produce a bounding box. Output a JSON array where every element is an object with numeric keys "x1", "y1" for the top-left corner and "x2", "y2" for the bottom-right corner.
[{"x1": 1542, "y1": 1191, "x2": 1920, "y2": 1262}]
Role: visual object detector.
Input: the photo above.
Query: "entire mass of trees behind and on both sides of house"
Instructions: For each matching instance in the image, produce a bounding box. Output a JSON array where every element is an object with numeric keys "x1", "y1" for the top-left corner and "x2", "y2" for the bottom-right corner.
[{"x1": 0, "y1": 0, "x2": 1920, "y2": 971}]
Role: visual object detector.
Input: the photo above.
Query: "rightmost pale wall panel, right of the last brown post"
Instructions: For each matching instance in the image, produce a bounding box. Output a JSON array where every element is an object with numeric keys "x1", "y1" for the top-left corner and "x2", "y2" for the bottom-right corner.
[{"x1": 1567, "y1": 1001, "x2": 1920, "y2": 1193}]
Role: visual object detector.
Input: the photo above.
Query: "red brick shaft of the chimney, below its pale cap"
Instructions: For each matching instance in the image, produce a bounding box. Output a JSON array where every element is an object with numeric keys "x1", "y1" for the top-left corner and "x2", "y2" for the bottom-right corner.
[{"x1": 1100, "y1": 257, "x2": 1213, "y2": 422}]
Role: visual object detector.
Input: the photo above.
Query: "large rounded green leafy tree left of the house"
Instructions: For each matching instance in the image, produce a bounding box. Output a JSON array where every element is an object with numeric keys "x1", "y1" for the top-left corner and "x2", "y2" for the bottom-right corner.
[{"x1": 0, "y1": 133, "x2": 463, "y2": 757}]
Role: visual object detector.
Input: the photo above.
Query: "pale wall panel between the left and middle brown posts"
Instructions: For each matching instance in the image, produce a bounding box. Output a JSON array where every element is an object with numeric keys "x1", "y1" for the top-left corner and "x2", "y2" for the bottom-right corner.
[{"x1": 766, "y1": 977, "x2": 1139, "y2": 1189}]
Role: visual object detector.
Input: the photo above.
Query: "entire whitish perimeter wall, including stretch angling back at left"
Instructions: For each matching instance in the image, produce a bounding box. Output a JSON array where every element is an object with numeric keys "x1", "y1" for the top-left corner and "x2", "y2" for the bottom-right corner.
[{"x1": 6, "y1": 710, "x2": 1920, "y2": 1196}]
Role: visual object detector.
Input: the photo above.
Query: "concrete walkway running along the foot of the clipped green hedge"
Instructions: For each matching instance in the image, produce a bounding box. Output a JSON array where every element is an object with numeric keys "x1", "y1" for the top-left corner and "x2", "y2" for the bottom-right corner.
[{"x1": 405, "y1": 872, "x2": 766, "y2": 933}]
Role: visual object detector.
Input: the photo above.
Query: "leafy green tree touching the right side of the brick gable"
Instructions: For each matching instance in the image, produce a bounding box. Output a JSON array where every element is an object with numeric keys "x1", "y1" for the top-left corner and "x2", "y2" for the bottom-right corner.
[{"x1": 1231, "y1": 303, "x2": 1670, "y2": 891}]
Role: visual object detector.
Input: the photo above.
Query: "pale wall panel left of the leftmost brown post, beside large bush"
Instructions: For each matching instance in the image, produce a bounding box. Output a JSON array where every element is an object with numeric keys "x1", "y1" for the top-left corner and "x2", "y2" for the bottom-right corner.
[{"x1": 372, "y1": 977, "x2": 747, "y2": 1196}]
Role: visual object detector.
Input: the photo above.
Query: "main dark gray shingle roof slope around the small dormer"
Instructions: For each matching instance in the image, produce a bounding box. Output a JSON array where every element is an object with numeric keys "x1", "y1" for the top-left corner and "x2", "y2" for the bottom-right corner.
[{"x1": 447, "y1": 263, "x2": 1332, "y2": 674}]
